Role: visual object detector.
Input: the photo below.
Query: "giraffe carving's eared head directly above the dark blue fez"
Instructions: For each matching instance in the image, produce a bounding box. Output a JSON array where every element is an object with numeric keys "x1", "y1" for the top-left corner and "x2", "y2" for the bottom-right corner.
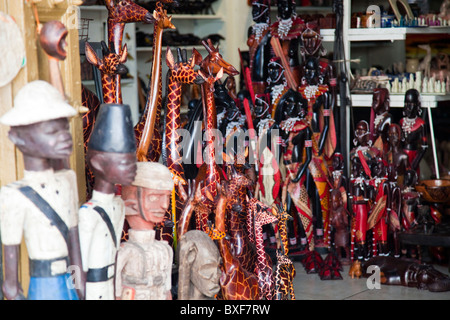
[{"x1": 86, "y1": 41, "x2": 128, "y2": 76}]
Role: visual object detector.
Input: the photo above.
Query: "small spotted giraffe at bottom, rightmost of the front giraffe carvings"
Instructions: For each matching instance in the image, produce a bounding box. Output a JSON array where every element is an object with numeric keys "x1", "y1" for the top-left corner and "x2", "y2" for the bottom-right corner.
[{"x1": 272, "y1": 205, "x2": 295, "y2": 300}]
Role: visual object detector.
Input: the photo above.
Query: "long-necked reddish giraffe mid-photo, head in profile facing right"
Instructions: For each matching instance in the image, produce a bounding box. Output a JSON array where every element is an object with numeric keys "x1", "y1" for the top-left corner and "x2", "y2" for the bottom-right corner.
[{"x1": 194, "y1": 39, "x2": 239, "y2": 208}]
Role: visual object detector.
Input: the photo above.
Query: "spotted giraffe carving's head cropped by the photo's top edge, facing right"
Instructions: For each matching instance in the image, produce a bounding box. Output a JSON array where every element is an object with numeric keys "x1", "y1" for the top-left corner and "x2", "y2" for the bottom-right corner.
[{"x1": 105, "y1": 0, "x2": 155, "y2": 23}]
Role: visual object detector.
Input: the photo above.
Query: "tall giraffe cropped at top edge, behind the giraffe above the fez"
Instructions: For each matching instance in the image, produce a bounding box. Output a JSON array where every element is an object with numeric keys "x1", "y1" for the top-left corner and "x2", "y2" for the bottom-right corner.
[{"x1": 104, "y1": 0, "x2": 154, "y2": 103}]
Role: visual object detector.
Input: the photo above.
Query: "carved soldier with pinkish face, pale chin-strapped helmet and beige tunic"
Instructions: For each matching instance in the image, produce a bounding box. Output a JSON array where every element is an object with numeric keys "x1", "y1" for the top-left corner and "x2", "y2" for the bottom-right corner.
[{"x1": 115, "y1": 162, "x2": 174, "y2": 300}]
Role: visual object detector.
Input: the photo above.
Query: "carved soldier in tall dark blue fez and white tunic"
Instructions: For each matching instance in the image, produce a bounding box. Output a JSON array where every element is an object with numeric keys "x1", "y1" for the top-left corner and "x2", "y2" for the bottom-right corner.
[{"x1": 79, "y1": 104, "x2": 136, "y2": 300}]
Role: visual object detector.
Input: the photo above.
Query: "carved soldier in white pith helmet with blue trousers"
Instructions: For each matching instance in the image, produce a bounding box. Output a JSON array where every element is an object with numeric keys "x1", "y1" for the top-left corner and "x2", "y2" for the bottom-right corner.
[{"x1": 0, "y1": 80, "x2": 84, "y2": 300}]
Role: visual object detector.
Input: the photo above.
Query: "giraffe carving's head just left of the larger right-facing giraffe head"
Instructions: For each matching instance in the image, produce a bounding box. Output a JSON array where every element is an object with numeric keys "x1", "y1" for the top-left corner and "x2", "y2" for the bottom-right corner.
[{"x1": 166, "y1": 47, "x2": 205, "y2": 84}]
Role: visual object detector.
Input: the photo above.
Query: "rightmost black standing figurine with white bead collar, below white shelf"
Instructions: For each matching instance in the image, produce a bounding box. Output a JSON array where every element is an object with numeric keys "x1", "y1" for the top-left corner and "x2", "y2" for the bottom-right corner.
[{"x1": 400, "y1": 89, "x2": 428, "y2": 179}]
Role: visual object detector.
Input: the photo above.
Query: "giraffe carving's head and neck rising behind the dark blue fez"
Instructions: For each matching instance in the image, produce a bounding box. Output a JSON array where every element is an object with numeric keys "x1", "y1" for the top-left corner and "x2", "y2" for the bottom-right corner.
[{"x1": 86, "y1": 41, "x2": 128, "y2": 104}]
